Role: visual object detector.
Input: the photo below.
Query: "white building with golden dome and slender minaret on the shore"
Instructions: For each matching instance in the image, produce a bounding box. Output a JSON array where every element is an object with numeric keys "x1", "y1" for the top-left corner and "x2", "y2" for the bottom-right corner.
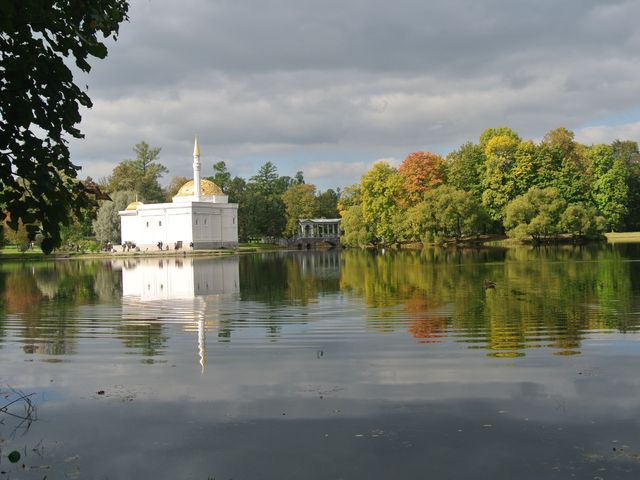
[{"x1": 118, "y1": 138, "x2": 238, "y2": 249}]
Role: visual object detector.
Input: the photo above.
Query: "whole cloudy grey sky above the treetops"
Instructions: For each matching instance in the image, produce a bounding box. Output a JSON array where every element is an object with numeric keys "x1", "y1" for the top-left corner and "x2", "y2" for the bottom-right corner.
[{"x1": 72, "y1": 0, "x2": 640, "y2": 189}]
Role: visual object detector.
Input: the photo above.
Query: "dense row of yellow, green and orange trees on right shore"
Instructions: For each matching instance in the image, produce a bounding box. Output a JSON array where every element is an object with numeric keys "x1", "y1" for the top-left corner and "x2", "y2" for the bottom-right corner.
[{"x1": 339, "y1": 127, "x2": 640, "y2": 246}]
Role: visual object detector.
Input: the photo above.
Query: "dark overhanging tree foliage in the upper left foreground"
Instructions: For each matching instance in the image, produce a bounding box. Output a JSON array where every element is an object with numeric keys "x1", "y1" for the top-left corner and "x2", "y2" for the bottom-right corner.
[{"x1": 0, "y1": 0, "x2": 128, "y2": 253}]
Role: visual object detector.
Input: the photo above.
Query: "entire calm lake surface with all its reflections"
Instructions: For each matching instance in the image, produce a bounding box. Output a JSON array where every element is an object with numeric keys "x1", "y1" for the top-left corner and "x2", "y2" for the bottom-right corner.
[{"x1": 0, "y1": 244, "x2": 640, "y2": 480}]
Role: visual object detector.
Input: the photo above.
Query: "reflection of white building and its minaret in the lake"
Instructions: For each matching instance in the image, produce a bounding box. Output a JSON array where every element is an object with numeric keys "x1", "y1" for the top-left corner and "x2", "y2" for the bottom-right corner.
[{"x1": 113, "y1": 257, "x2": 240, "y2": 371}]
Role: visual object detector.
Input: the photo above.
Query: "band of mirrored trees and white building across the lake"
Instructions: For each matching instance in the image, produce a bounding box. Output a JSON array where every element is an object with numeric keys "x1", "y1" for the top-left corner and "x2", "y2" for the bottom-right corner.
[{"x1": 0, "y1": 244, "x2": 640, "y2": 358}]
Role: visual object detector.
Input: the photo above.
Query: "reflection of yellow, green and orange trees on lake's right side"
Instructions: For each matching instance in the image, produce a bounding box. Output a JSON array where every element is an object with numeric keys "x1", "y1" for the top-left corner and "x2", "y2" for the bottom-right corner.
[{"x1": 341, "y1": 245, "x2": 640, "y2": 356}]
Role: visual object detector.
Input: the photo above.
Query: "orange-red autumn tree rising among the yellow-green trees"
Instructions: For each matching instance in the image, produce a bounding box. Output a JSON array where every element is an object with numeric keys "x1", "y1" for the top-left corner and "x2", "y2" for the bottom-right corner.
[{"x1": 399, "y1": 152, "x2": 444, "y2": 205}]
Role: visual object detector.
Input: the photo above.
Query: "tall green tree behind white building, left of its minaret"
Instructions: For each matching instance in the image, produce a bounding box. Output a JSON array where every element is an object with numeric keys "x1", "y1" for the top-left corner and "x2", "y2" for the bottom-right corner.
[{"x1": 107, "y1": 140, "x2": 168, "y2": 202}]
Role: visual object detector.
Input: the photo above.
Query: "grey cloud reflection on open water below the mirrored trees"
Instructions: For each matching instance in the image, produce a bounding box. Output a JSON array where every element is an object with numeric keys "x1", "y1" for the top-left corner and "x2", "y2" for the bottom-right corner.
[{"x1": 11, "y1": 345, "x2": 640, "y2": 479}]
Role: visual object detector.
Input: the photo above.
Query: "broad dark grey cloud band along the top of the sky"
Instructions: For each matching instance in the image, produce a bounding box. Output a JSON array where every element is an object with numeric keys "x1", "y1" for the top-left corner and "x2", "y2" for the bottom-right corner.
[{"x1": 90, "y1": 0, "x2": 640, "y2": 85}]
